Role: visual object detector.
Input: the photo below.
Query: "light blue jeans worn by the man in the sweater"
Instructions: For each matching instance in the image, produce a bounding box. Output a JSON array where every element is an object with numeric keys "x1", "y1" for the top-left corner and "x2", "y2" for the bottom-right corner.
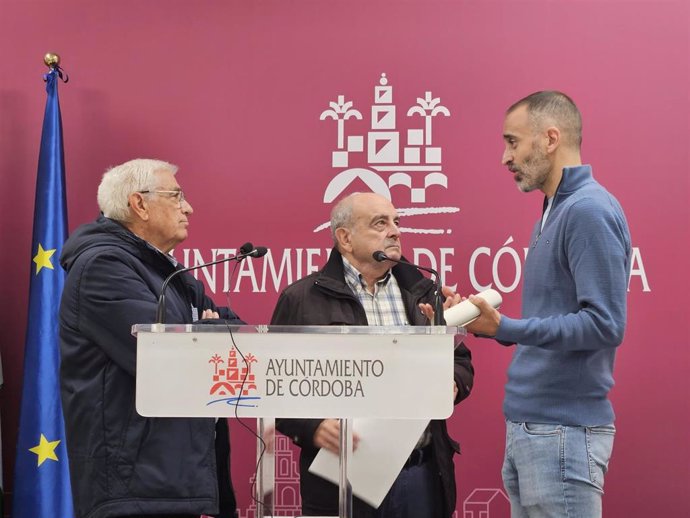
[{"x1": 502, "y1": 421, "x2": 616, "y2": 518}]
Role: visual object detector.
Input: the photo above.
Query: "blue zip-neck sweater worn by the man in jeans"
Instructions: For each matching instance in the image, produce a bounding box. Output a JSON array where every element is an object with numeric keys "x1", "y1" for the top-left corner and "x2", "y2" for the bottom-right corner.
[{"x1": 496, "y1": 165, "x2": 631, "y2": 426}]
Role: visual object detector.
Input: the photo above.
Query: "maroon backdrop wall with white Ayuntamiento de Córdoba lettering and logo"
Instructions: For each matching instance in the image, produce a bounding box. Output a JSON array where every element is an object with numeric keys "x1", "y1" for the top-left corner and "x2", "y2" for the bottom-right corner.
[{"x1": 0, "y1": 0, "x2": 690, "y2": 518}]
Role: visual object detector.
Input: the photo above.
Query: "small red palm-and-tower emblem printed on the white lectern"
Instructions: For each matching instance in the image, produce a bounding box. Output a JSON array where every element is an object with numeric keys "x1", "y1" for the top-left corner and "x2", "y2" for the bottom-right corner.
[{"x1": 207, "y1": 347, "x2": 261, "y2": 407}]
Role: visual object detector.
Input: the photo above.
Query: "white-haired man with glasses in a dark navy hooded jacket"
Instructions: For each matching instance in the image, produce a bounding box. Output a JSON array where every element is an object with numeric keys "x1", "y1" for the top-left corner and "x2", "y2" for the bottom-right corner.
[{"x1": 60, "y1": 159, "x2": 241, "y2": 518}]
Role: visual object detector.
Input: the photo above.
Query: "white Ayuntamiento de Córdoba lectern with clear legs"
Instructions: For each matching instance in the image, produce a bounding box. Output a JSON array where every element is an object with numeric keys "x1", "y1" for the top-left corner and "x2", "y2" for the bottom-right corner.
[{"x1": 132, "y1": 321, "x2": 464, "y2": 518}]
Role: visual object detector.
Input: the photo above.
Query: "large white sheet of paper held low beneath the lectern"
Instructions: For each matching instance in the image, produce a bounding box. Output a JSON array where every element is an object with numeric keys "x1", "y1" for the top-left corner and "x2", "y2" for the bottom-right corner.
[{"x1": 309, "y1": 419, "x2": 429, "y2": 508}]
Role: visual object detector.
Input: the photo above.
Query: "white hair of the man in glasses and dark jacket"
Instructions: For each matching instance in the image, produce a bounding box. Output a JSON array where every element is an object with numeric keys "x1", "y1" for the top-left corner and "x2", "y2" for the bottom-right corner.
[{"x1": 97, "y1": 158, "x2": 177, "y2": 222}]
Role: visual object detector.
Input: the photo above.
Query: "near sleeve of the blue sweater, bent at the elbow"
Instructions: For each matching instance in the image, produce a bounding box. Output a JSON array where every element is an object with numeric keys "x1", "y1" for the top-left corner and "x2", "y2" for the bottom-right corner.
[{"x1": 496, "y1": 198, "x2": 630, "y2": 351}]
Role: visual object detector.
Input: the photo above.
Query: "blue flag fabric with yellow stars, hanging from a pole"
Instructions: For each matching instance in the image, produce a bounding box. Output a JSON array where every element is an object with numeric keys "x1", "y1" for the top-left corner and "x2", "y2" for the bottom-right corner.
[{"x1": 12, "y1": 69, "x2": 74, "y2": 518}]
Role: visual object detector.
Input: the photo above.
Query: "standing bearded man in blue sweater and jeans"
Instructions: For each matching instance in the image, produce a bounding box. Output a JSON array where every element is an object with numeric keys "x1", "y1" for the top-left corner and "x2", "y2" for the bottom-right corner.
[{"x1": 467, "y1": 92, "x2": 631, "y2": 518}]
